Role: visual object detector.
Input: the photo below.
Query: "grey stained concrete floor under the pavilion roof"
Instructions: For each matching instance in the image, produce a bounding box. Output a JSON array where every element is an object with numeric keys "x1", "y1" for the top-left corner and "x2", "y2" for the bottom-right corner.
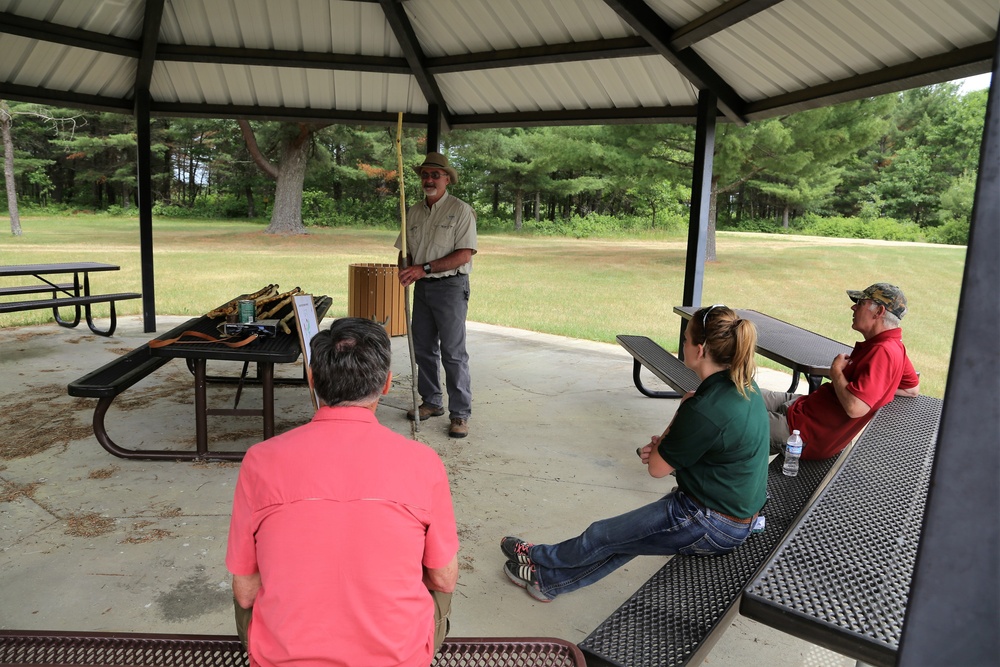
[{"x1": 0, "y1": 317, "x2": 853, "y2": 667}]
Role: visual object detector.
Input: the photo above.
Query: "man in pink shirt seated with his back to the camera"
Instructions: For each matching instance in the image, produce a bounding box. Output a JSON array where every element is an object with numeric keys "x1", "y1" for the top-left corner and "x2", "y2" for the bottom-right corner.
[{"x1": 226, "y1": 318, "x2": 458, "y2": 667}]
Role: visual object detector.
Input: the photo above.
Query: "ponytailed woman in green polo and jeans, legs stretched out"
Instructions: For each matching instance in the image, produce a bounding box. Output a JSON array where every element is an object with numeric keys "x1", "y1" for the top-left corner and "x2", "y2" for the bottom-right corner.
[{"x1": 500, "y1": 306, "x2": 769, "y2": 602}]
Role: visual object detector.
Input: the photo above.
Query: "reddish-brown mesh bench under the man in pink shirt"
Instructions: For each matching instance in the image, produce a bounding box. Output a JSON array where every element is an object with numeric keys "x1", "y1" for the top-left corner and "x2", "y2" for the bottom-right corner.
[{"x1": 0, "y1": 630, "x2": 586, "y2": 667}]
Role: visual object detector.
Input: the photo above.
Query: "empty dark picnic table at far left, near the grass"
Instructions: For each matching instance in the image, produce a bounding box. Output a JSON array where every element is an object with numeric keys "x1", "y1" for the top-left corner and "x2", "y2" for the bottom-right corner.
[{"x1": 0, "y1": 262, "x2": 142, "y2": 336}]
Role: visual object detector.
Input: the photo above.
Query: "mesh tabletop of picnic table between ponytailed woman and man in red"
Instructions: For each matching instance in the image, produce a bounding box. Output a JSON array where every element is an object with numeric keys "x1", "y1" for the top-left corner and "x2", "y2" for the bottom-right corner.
[{"x1": 674, "y1": 306, "x2": 854, "y2": 393}]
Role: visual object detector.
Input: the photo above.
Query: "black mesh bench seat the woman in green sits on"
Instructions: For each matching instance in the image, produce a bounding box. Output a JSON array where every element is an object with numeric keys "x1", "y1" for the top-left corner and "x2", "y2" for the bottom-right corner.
[{"x1": 580, "y1": 457, "x2": 836, "y2": 667}]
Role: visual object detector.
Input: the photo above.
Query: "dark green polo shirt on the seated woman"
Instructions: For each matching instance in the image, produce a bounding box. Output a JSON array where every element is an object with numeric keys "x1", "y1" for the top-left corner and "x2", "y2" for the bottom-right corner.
[{"x1": 659, "y1": 371, "x2": 770, "y2": 519}]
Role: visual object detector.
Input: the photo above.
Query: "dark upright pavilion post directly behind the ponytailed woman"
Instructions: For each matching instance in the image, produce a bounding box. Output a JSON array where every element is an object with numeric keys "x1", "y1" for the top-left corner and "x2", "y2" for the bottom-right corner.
[{"x1": 678, "y1": 90, "x2": 717, "y2": 359}]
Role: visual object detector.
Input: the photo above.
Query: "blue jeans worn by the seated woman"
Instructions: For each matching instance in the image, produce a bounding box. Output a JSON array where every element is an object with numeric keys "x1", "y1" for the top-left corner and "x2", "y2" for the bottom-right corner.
[{"x1": 528, "y1": 490, "x2": 750, "y2": 598}]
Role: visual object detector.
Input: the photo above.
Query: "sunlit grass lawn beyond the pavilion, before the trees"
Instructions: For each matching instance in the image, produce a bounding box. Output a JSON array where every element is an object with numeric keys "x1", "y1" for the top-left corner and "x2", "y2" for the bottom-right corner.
[{"x1": 0, "y1": 216, "x2": 965, "y2": 396}]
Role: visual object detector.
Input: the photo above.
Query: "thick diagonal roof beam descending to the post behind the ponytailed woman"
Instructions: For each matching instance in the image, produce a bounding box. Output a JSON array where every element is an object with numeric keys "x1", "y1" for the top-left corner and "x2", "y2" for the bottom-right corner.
[{"x1": 604, "y1": 0, "x2": 747, "y2": 125}]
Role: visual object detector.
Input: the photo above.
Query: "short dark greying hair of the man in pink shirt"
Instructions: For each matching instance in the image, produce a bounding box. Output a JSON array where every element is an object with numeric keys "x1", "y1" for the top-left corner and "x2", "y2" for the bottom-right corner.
[{"x1": 309, "y1": 317, "x2": 392, "y2": 406}]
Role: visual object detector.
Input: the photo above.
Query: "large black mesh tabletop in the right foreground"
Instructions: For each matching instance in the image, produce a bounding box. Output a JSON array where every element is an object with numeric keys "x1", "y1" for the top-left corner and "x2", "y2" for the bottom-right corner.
[{"x1": 740, "y1": 396, "x2": 941, "y2": 665}]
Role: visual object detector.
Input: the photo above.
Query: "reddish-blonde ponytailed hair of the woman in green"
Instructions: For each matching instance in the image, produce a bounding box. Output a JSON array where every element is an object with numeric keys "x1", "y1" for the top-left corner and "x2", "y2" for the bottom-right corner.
[{"x1": 688, "y1": 306, "x2": 757, "y2": 398}]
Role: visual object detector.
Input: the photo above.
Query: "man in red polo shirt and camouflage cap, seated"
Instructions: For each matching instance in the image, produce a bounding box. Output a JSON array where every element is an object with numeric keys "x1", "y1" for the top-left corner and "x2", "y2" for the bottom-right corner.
[{"x1": 762, "y1": 283, "x2": 920, "y2": 459}]
